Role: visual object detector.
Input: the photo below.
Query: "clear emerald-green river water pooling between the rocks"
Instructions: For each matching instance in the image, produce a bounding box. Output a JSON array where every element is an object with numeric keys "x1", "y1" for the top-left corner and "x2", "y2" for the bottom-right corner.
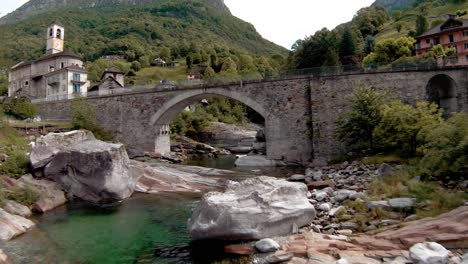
[{"x1": 0, "y1": 156, "x2": 300, "y2": 264}]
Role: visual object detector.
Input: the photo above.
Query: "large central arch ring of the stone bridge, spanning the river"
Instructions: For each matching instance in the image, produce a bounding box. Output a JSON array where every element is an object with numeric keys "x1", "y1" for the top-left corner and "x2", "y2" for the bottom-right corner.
[{"x1": 150, "y1": 88, "x2": 279, "y2": 159}]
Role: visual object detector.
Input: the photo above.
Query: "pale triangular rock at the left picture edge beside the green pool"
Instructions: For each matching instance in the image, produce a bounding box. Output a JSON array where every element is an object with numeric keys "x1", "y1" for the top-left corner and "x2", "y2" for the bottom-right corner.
[{"x1": 0, "y1": 208, "x2": 35, "y2": 241}]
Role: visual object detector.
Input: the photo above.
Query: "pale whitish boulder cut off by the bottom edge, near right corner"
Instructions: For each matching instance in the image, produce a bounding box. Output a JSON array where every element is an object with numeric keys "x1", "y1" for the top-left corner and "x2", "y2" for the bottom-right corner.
[{"x1": 410, "y1": 242, "x2": 450, "y2": 264}]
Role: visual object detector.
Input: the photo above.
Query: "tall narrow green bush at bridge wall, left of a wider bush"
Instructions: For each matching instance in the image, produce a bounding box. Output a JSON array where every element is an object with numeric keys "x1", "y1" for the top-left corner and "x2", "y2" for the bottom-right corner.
[{"x1": 337, "y1": 85, "x2": 384, "y2": 149}]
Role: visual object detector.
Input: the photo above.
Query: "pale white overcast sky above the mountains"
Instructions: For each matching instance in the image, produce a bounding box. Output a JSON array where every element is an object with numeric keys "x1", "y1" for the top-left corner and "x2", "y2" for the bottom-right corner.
[{"x1": 0, "y1": 0, "x2": 375, "y2": 49}]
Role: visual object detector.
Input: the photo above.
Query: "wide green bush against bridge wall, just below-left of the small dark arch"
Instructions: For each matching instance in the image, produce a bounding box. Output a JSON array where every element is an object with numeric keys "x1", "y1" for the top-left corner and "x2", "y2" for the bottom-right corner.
[{"x1": 375, "y1": 100, "x2": 443, "y2": 155}]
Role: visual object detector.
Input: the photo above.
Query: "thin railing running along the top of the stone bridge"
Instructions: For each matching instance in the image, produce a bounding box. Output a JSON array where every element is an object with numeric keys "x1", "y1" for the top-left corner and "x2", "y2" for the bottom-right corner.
[{"x1": 32, "y1": 58, "x2": 468, "y2": 103}]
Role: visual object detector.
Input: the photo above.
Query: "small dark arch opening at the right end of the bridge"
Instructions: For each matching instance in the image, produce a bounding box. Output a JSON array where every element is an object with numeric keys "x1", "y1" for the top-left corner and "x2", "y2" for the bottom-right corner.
[{"x1": 426, "y1": 74, "x2": 459, "y2": 117}]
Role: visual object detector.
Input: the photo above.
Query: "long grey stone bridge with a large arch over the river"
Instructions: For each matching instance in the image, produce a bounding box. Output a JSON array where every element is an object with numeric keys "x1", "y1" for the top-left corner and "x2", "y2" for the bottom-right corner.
[{"x1": 37, "y1": 67, "x2": 468, "y2": 164}]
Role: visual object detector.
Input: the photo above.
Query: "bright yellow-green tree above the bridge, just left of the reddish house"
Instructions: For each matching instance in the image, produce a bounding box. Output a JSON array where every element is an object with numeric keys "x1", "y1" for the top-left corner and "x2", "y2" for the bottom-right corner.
[{"x1": 363, "y1": 37, "x2": 415, "y2": 66}]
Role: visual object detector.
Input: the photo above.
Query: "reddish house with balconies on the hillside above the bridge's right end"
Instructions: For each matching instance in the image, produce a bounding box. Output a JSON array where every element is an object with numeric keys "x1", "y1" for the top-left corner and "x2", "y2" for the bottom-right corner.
[{"x1": 416, "y1": 15, "x2": 468, "y2": 65}]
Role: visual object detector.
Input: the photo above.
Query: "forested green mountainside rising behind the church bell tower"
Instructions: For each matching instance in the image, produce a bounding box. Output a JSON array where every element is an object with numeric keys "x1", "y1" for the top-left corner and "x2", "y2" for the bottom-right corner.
[{"x1": 0, "y1": 0, "x2": 287, "y2": 69}]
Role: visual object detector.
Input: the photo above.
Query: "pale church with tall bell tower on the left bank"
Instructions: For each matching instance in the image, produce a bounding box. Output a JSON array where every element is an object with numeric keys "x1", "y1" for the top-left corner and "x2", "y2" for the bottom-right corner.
[{"x1": 8, "y1": 20, "x2": 90, "y2": 101}]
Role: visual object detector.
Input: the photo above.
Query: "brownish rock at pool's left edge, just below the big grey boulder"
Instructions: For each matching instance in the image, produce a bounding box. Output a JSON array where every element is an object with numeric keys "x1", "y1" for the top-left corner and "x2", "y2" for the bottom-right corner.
[{"x1": 18, "y1": 174, "x2": 67, "y2": 213}]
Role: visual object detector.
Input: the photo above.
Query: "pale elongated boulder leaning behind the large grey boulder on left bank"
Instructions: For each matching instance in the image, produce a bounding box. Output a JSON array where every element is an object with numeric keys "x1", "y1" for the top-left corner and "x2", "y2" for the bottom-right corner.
[{"x1": 29, "y1": 130, "x2": 95, "y2": 177}]
